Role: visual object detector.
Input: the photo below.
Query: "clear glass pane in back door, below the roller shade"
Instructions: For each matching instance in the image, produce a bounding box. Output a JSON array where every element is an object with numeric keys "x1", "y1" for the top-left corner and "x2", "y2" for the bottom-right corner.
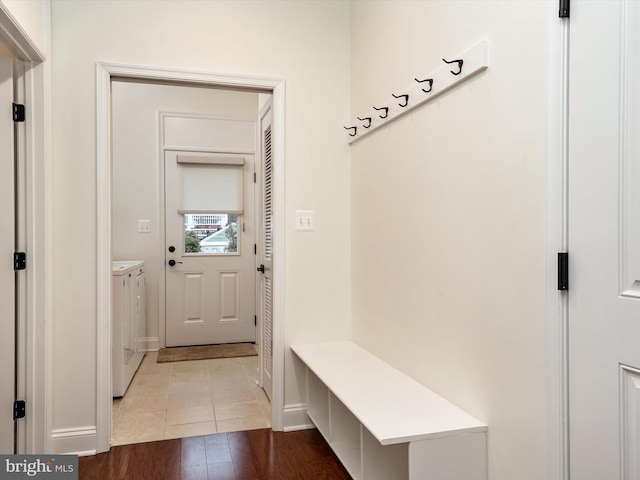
[{"x1": 184, "y1": 213, "x2": 240, "y2": 255}]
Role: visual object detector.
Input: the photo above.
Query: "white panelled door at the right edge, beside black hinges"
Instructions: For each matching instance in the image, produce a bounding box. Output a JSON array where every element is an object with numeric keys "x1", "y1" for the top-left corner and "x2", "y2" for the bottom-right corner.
[{"x1": 568, "y1": 0, "x2": 640, "y2": 480}]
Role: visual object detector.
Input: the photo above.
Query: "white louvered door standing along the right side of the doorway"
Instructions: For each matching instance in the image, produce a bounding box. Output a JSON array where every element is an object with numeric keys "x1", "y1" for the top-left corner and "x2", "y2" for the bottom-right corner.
[{"x1": 259, "y1": 102, "x2": 273, "y2": 399}]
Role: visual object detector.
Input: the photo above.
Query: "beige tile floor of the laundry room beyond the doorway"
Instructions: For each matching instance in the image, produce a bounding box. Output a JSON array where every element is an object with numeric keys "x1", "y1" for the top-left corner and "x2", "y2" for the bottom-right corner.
[{"x1": 112, "y1": 352, "x2": 271, "y2": 445}]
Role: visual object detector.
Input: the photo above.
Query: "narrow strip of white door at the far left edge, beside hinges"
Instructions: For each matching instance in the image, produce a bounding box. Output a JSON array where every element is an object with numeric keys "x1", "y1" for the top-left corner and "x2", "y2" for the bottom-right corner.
[{"x1": 0, "y1": 56, "x2": 16, "y2": 454}]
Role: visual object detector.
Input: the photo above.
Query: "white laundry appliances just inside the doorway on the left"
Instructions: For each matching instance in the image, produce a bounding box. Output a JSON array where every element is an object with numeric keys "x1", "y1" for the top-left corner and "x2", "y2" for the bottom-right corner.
[{"x1": 111, "y1": 260, "x2": 147, "y2": 397}]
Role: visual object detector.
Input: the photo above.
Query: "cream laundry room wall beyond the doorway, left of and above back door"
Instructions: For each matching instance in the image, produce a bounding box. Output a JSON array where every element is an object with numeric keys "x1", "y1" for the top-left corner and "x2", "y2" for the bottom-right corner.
[{"x1": 111, "y1": 81, "x2": 258, "y2": 346}]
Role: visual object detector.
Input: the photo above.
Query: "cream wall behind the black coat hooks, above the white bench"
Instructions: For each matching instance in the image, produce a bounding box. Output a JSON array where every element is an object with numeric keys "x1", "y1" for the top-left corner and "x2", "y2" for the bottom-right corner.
[{"x1": 351, "y1": 1, "x2": 549, "y2": 480}]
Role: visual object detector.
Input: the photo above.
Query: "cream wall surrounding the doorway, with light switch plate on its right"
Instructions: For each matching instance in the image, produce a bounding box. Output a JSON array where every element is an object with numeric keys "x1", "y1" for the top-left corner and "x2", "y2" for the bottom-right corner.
[{"x1": 52, "y1": 1, "x2": 350, "y2": 449}]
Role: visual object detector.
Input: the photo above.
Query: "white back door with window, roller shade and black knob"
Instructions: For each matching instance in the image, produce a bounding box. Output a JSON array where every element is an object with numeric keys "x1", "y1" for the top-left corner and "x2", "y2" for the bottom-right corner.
[{"x1": 165, "y1": 150, "x2": 256, "y2": 346}]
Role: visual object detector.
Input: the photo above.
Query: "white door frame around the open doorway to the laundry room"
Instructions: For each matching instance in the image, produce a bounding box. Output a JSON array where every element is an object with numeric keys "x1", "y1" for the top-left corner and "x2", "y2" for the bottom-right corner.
[{"x1": 96, "y1": 63, "x2": 285, "y2": 453}]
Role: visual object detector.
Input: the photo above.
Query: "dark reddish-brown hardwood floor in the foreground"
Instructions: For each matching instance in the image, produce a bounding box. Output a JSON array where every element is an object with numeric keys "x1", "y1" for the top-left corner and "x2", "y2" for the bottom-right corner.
[{"x1": 78, "y1": 429, "x2": 351, "y2": 480}]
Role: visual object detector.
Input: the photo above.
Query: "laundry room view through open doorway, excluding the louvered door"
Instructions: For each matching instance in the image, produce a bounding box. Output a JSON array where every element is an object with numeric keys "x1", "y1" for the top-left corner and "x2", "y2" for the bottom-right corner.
[{"x1": 111, "y1": 79, "x2": 271, "y2": 445}]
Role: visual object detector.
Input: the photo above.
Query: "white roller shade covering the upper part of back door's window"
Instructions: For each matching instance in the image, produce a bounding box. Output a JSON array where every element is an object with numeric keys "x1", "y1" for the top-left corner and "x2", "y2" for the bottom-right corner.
[{"x1": 178, "y1": 156, "x2": 244, "y2": 215}]
